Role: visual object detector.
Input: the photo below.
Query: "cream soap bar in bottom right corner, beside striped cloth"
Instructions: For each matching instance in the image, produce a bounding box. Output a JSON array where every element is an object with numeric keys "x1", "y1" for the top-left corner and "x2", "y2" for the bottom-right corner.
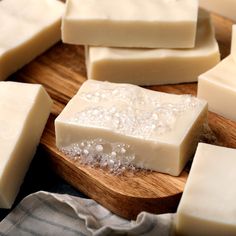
[{"x1": 176, "y1": 143, "x2": 236, "y2": 236}]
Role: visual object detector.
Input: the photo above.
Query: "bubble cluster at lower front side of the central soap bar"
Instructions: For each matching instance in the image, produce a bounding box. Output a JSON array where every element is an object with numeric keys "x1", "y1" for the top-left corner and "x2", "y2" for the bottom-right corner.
[{"x1": 61, "y1": 139, "x2": 136, "y2": 175}]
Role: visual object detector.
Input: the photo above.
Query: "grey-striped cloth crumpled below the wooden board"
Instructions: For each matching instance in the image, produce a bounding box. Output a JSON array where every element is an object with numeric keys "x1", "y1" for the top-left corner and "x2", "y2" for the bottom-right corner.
[{"x1": 0, "y1": 192, "x2": 174, "y2": 236}]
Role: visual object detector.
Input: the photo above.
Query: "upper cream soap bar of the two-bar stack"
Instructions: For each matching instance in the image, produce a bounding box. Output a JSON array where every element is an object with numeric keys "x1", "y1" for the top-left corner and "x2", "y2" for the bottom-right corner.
[{"x1": 62, "y1": 0, "x2": 198, "y2": 48}]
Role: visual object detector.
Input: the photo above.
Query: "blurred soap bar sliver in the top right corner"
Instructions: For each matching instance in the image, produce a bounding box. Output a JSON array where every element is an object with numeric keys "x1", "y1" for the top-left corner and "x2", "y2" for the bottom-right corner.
[{"x1": 199, "y1": 0, "x2": 236, "y2": 21}]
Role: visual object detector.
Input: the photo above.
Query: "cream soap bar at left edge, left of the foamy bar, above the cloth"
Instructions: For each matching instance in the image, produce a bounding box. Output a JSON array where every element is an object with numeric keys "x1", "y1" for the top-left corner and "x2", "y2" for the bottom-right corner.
[{"x1": 0, "y1": 81, "x2": 52, "y2": 208}]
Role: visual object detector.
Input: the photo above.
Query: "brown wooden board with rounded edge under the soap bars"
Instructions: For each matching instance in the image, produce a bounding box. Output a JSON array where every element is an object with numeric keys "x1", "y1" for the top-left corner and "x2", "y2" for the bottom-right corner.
[{"x1": 10, "y1": 13, "x2": 236, "y2": 219}]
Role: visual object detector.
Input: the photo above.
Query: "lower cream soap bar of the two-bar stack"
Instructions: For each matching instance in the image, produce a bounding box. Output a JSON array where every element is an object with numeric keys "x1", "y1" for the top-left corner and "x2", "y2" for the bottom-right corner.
[{"x1": 86, "y1": 10, "x2": 220, "y2": 85}]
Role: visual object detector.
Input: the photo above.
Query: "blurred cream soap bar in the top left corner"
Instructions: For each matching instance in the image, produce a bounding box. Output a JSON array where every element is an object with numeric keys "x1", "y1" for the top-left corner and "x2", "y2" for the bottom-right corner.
[{"x1": 0, "y1": 0, "x2": 64, "y2": 80}]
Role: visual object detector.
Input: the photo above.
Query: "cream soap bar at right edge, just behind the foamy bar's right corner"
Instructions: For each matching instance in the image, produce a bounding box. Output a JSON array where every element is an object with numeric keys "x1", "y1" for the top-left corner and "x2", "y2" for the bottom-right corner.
[{"x1": 197, "y1": 56, "x2": 236, "y2": 121}]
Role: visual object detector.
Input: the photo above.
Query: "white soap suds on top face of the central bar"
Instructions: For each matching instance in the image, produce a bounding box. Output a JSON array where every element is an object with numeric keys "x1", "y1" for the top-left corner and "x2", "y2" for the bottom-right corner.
[{"x1": 69, "y1": 91, "x2": 199, "y2": 139}]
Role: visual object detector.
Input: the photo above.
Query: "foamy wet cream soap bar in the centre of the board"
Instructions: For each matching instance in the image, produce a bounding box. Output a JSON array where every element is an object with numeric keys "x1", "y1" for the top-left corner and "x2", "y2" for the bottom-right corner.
[{"x1": 55, "y1": 80, "x2": 207, "y2": 176}]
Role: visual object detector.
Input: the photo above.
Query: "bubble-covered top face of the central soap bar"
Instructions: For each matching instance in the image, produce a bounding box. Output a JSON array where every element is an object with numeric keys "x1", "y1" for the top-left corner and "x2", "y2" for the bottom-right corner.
[{"x1": 60, "y1": 80, "x2": 206, "y2": 142}]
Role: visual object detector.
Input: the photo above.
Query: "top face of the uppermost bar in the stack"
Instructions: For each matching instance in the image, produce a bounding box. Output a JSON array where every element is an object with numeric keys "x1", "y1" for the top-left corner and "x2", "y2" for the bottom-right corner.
[{"x1": 66, "y1": 0, "x2": 198, "y2": 22}]
